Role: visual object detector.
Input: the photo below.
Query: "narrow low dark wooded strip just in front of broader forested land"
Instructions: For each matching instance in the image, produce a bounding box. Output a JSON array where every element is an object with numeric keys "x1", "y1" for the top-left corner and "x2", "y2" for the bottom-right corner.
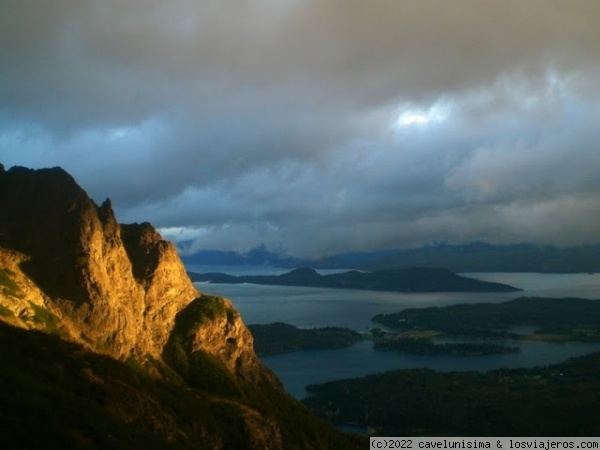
[{"x1": 372, "y1": 329, "x2": 519, "y2": 356}]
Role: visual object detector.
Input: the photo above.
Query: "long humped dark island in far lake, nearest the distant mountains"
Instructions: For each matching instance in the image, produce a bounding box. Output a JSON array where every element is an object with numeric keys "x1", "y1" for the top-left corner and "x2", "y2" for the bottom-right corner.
[{"x1": 189, "y1": 268, "x2": 520, "y2": 292}]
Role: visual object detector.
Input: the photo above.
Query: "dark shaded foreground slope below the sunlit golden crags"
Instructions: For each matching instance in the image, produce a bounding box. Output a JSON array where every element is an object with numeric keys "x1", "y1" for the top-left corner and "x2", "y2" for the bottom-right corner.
[{"x1": 0, "y1": 321, "x2": 367, "y2": 449}]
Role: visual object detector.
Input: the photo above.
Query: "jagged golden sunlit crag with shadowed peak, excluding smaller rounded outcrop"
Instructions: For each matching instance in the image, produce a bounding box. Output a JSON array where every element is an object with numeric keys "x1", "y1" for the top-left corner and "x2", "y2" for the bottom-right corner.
[{"x1": 0, "y1": 168, "x2": 199, "y2": 358}]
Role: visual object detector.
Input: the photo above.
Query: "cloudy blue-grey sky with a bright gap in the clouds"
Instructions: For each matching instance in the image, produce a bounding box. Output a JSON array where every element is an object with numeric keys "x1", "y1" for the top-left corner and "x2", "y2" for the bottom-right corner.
[{"x1": 0, "y1": 0, "x2": 600, "y2": 257}]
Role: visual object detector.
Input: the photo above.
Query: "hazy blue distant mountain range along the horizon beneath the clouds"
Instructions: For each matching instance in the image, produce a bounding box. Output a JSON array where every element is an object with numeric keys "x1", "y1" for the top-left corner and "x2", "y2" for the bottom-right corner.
[{"x1": 183, "y1": 242, "x2": 600, "y2": 273}]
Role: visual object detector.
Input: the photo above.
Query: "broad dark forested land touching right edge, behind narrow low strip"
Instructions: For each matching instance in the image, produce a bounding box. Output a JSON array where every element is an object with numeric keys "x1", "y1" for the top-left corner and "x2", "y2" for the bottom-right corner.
[{"x1": 373, "y1": 297, "x2": 600, "y2": 342}]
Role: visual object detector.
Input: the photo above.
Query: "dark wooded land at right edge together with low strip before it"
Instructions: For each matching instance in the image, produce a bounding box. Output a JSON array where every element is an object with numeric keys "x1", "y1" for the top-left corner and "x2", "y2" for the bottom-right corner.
[{"x1": 371, "y1": 297, "x2": 600, "y2": 356}]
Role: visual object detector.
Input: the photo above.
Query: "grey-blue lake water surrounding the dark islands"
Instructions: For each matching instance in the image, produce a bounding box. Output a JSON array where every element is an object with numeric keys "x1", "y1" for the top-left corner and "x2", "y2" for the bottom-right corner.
[{"x1": 187, "y1": 266, "x2": 600, "y2": 398}]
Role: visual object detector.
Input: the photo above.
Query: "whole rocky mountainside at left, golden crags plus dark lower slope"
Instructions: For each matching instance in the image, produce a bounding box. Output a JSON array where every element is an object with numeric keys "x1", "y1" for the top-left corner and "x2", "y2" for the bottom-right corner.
[{"x1": 0, "y1": 164, "x2": 363, "y2": 449}]
